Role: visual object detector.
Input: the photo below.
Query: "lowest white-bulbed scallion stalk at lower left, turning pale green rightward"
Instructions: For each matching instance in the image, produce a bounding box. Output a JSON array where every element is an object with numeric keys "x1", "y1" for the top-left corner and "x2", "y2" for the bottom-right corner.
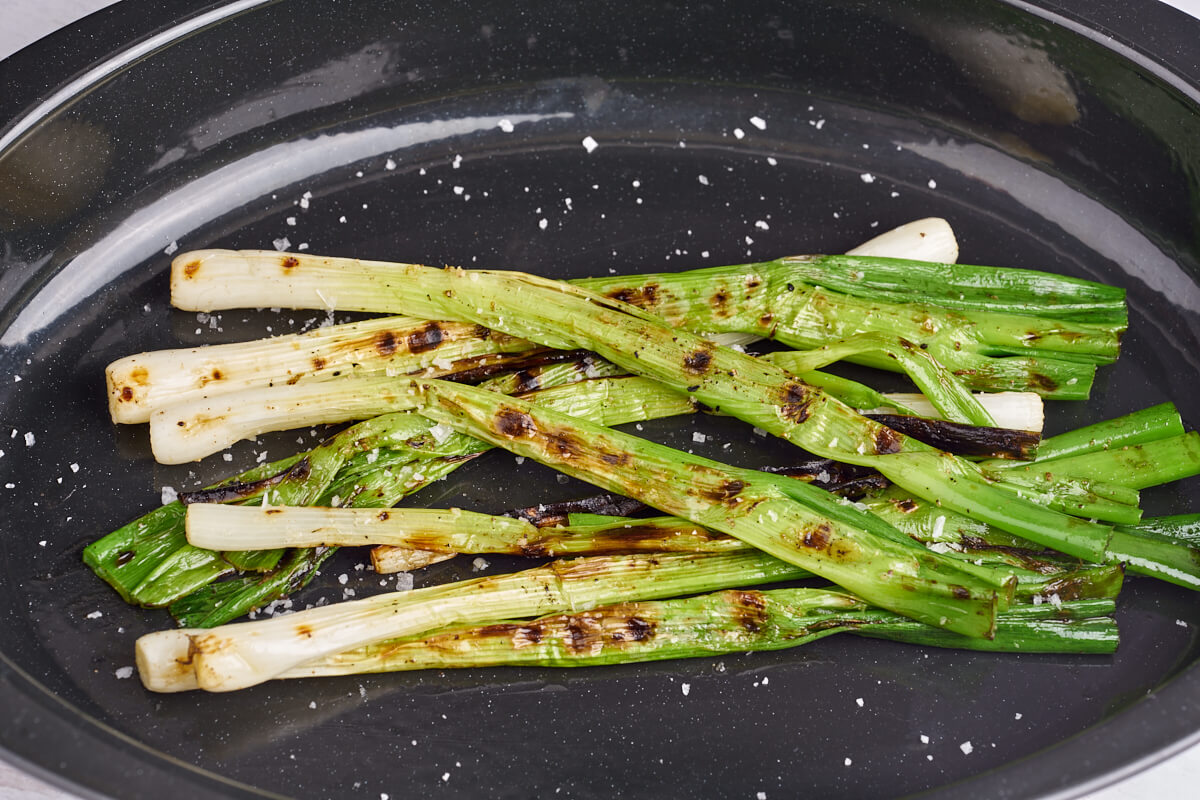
[{"x1": 137, "y1": 552, "x2": 809, "y2": 691}]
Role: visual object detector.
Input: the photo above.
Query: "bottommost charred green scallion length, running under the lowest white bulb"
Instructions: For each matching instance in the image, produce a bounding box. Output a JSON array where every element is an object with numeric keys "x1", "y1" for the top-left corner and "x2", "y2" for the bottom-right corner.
[{"x1": 288, "y1": 588, "x2": 1117, "y2": 678}]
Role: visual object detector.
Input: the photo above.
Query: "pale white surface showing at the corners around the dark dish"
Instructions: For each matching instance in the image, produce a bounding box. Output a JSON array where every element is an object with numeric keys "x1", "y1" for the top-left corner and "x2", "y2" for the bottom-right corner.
[{"x1": 0, "y1": 0, "x2": 1200, "y2": 800}]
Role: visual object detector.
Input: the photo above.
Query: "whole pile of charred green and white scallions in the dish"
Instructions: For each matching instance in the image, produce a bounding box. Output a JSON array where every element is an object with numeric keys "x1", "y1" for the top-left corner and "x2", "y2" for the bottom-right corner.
[{"x1": 77, "y1": 219, "x2": 1200, "y2": 691}]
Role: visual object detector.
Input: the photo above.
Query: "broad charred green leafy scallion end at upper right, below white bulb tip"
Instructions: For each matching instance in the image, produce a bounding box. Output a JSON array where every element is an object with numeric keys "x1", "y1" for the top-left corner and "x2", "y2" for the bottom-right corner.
[{"x1": 576, "y1": 255, "x2": 1126, "y2": 399}]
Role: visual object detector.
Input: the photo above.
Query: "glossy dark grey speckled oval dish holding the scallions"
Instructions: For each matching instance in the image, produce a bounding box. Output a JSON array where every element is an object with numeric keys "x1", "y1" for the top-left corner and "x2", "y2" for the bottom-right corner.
[{"x1": 0, "y1": 0, "x2": 1200, "y2": 800}]
